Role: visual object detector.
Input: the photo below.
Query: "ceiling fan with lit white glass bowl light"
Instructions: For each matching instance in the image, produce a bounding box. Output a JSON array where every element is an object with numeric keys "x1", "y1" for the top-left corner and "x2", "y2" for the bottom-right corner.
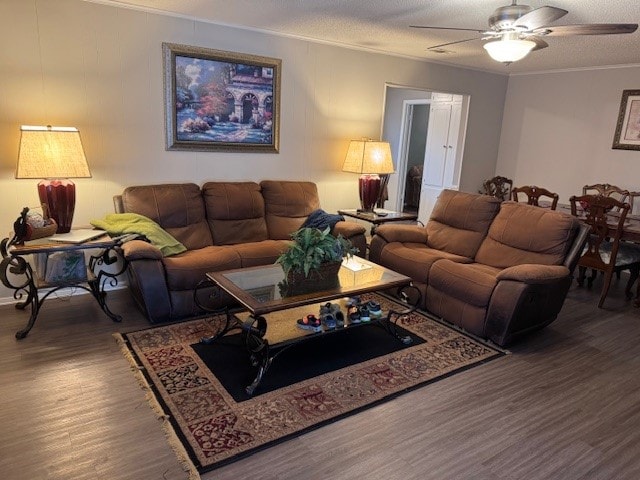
[{"x1": 411, "y1": 0, "x2": 638, "y2": 64}]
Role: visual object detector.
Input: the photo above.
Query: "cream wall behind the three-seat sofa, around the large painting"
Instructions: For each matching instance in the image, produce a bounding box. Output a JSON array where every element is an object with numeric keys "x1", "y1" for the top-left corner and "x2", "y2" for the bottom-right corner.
[{"x1": 0, "y1": 0, "x2": 507, "y2": 299}]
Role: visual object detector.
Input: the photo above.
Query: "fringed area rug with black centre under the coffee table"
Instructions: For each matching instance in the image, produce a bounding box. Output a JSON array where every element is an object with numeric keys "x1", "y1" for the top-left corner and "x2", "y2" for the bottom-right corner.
[{"x1": 116, "y1": 294, "x2": 503, "y2": 478}]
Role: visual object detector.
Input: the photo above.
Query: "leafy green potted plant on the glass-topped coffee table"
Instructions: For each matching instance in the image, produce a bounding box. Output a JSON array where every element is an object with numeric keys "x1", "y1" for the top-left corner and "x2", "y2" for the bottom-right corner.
[{"x1": 276, "y1": 227, "x2": 358, "y2": 284}]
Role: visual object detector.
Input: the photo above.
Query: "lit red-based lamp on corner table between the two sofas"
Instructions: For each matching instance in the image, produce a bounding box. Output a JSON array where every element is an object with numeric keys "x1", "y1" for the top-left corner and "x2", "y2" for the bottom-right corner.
[{"x1": 342, "y1": 139, "x2": 394, "y2": 212}]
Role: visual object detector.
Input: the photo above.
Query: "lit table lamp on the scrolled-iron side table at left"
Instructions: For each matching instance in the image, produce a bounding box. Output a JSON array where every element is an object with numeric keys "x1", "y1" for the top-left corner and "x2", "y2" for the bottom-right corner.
[{"x1": 16, "y1": 125, "x2": 91, "y2": 233}]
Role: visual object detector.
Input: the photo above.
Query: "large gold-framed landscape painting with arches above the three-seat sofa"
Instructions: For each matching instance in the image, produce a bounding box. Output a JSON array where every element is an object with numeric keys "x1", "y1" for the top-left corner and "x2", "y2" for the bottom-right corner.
[{"x1": 162, "y1": 43, "x2": 282, "y2": 153}]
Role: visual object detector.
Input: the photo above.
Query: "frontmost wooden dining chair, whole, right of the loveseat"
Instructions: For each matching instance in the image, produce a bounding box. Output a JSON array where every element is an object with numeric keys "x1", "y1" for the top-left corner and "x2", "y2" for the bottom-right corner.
[{"x1": 569, "y1": 195, "x2": 640, "y2": 308}]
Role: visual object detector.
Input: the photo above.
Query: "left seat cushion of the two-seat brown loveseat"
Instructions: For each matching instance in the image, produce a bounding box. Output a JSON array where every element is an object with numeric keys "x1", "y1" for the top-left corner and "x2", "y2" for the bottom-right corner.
[{"x1": 380, "y1": 242, "x2": 471, "y2": 283}]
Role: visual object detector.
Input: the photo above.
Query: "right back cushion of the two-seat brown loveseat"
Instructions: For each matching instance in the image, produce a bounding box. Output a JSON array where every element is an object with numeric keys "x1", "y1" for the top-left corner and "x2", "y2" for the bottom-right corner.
[{"x1": 475, "y1": 201, "x2": 576, "y2": 268}]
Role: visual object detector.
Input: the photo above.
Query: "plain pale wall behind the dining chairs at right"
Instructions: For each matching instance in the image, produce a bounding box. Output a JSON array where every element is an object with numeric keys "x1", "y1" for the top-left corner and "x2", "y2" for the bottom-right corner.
[{"x1": 496, "y1": 66, "x2": 640, "y2": 203}]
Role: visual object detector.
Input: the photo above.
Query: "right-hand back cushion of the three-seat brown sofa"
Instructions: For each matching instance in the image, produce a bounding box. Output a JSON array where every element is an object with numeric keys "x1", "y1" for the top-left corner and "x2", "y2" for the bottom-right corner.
[{"x1": 260, "y1": 180, "x2": 320, "y2": 240}]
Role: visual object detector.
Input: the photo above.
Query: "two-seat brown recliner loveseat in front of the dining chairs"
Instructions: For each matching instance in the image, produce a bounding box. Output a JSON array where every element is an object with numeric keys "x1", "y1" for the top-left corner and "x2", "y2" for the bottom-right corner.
[{"x1": 369, "y1": 190, "x2": 588, "y2": 346}]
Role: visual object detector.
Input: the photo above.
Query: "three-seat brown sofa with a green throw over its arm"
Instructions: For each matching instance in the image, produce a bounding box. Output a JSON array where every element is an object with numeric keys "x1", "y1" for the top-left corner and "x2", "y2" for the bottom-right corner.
[{"x1": 114, "y1": 180, "x2": 366, "y2": 323}]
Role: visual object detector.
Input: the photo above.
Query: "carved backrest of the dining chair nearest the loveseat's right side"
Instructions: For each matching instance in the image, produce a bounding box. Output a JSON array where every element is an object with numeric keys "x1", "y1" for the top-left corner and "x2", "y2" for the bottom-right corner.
[{"x1": 569, "y1": 195, "x2": 630, "y2": 271}]
